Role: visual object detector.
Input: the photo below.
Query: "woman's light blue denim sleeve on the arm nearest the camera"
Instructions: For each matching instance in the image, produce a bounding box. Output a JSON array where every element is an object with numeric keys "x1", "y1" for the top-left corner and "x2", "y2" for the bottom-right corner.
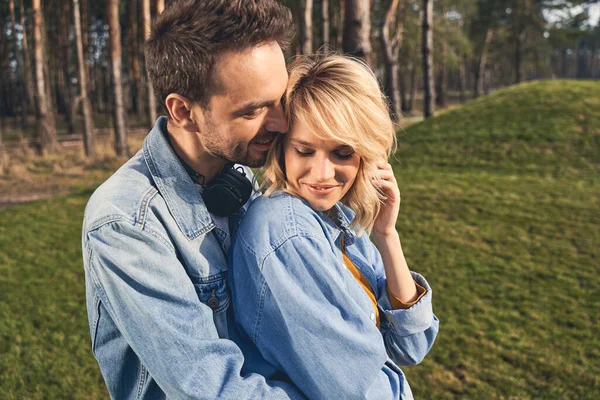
[{"x1": 230, "y1": 235, "x2": 405, "y2": 399}]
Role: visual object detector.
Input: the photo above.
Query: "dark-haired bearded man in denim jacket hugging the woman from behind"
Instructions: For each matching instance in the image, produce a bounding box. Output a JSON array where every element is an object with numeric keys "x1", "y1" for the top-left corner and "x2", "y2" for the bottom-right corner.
[{"x1": 83, "y1": 0, "x2": 301, "y2": 399}]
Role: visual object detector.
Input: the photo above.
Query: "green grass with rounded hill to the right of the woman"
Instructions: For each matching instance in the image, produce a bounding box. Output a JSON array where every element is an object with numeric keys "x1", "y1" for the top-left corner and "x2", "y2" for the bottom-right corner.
[{"x1": 394, "y1": 81, "x2": 600, "y2": 399}]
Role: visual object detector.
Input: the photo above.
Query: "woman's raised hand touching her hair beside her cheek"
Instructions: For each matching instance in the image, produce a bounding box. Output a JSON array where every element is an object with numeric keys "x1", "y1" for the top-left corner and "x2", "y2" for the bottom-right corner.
[{"x1": 371, "y1": 162, "x2": 400, "y2": 240}]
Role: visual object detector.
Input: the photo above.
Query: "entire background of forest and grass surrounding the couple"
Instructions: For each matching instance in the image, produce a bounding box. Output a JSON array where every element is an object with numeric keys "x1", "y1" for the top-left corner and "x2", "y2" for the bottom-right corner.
[{"x1": 0, "y1": 0, "x2": 600, "y2": 399}]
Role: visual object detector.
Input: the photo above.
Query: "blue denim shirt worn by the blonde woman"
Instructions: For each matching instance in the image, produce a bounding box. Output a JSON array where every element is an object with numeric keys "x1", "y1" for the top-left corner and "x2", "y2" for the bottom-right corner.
[{"x1": 229, "y1": 193, "x2": 439, "y2": 399}]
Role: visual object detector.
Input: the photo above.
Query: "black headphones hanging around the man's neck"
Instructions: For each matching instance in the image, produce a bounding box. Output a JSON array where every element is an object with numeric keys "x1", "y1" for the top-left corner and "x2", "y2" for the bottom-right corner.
[{"x1": 202, "y1": 163, "x2": 252, "y2": 217}]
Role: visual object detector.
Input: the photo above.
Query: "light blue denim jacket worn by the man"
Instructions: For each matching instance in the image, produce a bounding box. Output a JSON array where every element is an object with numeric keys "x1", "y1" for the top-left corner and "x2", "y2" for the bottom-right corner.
[{"x1": 83, "y1": 118, "x2": 301, "y2": 399}]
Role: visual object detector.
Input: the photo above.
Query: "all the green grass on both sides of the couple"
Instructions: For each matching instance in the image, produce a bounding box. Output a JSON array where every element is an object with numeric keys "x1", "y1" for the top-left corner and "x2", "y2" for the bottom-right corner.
[{"x1": 0, "y1": 81, "x2": 600, "y2": 399}]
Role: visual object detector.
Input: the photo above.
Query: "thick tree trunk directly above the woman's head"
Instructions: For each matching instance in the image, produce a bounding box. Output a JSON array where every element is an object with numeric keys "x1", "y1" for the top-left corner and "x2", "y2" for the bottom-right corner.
[{"x1": 342, "y1": 0, "x2": 372, "y2": 66}]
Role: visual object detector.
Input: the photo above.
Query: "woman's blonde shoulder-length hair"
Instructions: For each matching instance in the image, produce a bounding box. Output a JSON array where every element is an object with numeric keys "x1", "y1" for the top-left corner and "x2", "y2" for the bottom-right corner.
[{"x1": 261, "y1": 54, "x2": 396, "y2": 235}]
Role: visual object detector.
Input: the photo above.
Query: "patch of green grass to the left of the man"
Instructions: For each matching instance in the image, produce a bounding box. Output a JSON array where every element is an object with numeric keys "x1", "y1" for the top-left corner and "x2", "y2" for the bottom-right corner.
[{"x1": 0, "y1": 191, "x2": 108, "y2": 400}]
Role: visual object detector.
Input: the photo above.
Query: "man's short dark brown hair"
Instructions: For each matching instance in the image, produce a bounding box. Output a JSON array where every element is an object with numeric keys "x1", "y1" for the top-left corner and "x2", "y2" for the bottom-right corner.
[{"x1": 145, "y1": 0, "x2": 294, "y2": 106}]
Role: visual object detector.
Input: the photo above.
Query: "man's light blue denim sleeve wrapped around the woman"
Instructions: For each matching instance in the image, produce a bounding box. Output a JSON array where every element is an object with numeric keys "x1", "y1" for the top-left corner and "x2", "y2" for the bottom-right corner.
[{"x1": 84, "y1": 222, "x2": 302, "y2": 399}]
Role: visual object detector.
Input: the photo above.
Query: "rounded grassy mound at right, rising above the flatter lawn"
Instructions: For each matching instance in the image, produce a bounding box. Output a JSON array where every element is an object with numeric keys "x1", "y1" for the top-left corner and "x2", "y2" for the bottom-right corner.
[{"x1": 401, "y1": 80, "x2": 600, "y2": 175}]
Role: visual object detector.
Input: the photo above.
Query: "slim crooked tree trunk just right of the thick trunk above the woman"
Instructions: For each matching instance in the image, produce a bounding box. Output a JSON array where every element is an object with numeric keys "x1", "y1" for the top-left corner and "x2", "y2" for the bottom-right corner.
[{"x1": 379, "y1": 0, "x2": 404, "y2": 122}]
